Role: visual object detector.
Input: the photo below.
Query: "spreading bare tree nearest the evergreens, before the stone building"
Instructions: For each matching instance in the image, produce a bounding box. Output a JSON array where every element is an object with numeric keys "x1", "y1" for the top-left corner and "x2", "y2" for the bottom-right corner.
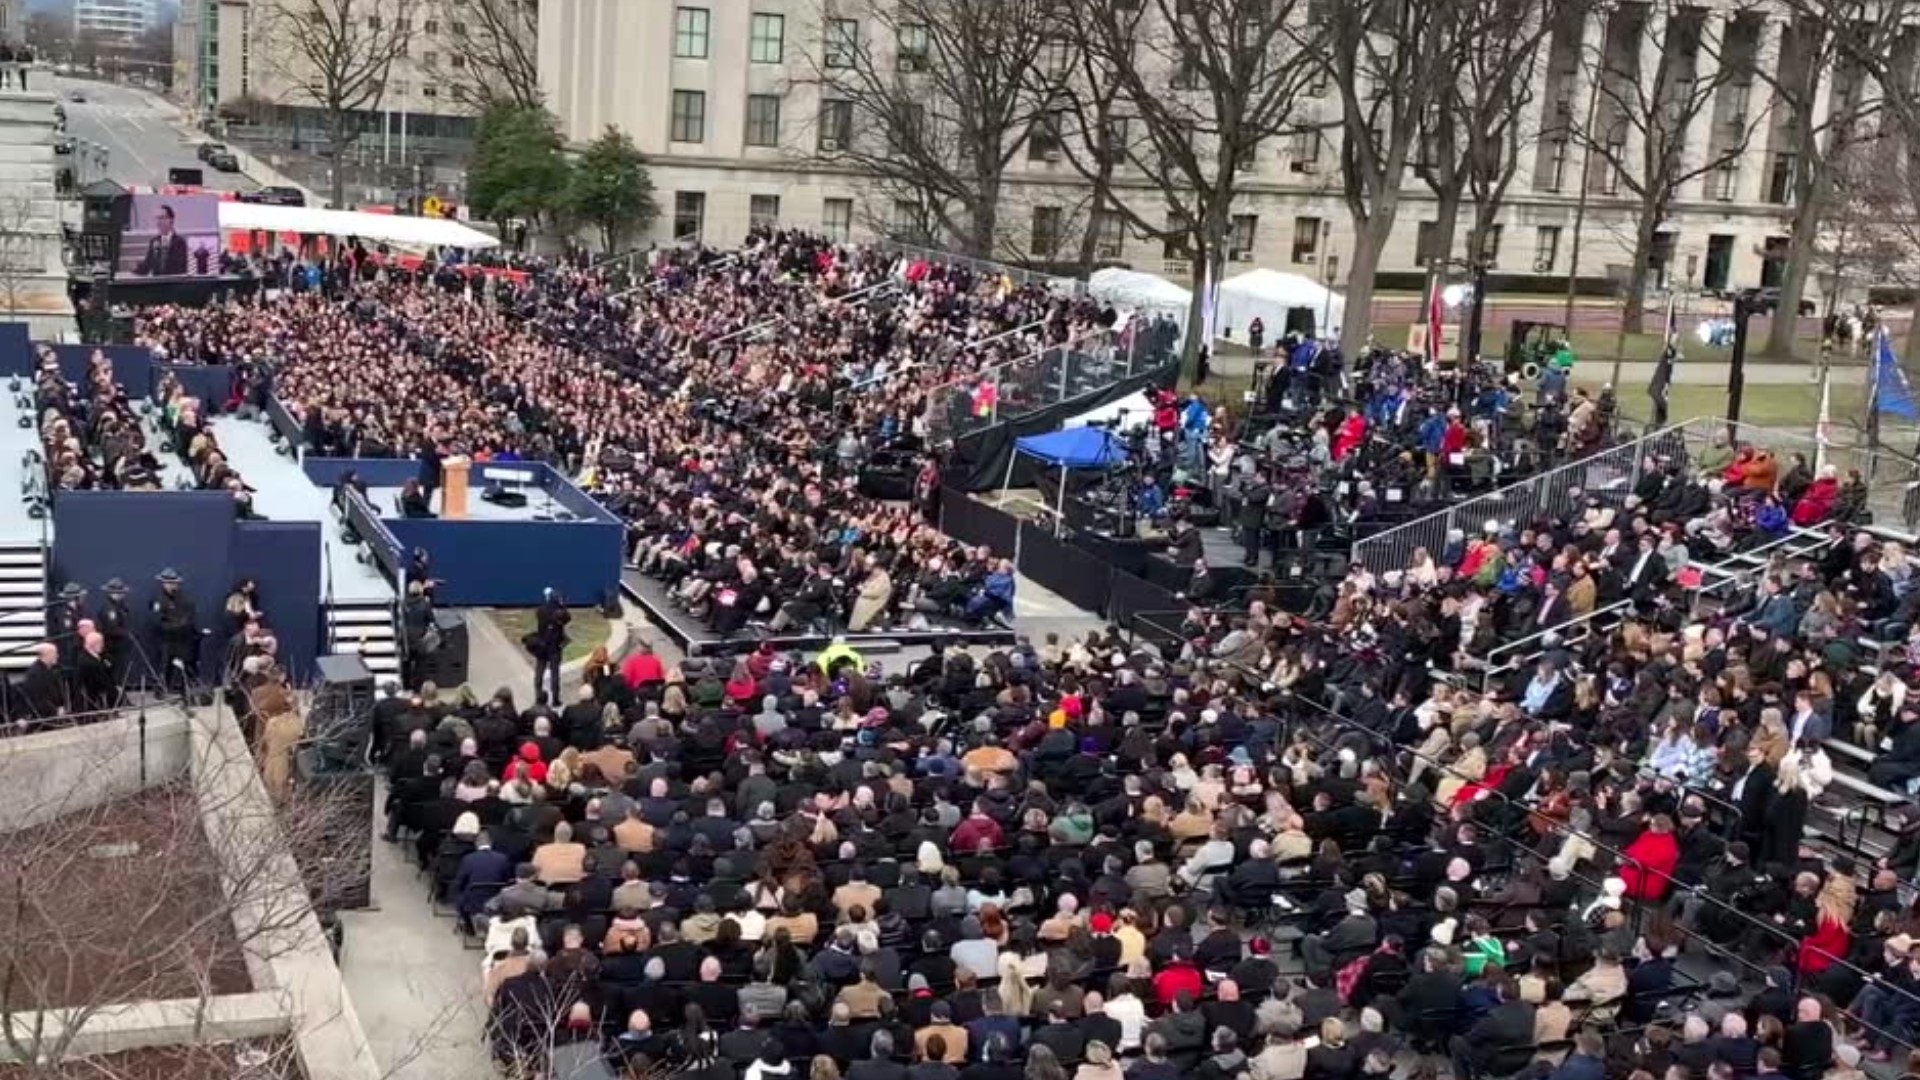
[{"x1": 799, "y1": 0, "x2": 1054, "y2": 258}]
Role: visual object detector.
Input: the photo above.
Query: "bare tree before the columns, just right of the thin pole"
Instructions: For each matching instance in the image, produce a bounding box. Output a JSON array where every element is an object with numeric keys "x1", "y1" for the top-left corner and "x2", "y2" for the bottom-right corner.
[{"x1": 1569, "y1": 0, "x2": 1766, "y2": 334}]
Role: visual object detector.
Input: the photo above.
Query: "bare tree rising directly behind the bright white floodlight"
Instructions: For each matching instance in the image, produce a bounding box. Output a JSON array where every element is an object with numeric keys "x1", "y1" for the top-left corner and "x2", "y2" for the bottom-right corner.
[{"x1": 1413, "y1": 0, "x2": 1557, "y2": 288}]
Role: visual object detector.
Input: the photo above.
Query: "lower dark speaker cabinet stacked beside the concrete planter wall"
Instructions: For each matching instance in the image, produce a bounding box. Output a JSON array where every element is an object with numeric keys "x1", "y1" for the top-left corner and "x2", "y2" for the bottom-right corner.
[{"x1": 292, "y1": 749, "x2": 372, "y2": 917}]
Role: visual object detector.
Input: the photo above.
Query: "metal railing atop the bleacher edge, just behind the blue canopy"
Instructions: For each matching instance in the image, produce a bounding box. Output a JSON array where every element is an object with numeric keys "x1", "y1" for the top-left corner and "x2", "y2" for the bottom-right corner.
[{"x1": 925, "y1": 325, "x2": 1173, "y2": 442}]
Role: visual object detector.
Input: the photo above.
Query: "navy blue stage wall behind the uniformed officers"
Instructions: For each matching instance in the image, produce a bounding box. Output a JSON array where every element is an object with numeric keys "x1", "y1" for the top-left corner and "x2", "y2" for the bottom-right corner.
[{"x1": 54, "y1": 492, "x2": 234, "y2": 682}]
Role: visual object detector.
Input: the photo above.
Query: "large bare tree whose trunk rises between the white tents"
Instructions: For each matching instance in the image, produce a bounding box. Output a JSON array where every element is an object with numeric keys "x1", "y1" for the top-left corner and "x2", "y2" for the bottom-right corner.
[{"x1": 1060, "y1": 0, "x2": 1323, "y2": 367}]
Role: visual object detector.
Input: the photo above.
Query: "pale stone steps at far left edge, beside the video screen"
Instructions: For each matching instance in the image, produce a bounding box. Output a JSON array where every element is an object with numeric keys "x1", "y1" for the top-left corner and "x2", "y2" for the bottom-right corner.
[{"x1": 0, "y1": 90, "x2": 75, "y2": 340}]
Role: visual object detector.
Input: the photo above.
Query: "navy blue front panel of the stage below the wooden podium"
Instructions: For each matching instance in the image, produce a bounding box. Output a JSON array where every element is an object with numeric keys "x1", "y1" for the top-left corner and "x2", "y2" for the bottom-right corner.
[{"x1": 386, "y1": 517, "x2": 626, "y2": 607}]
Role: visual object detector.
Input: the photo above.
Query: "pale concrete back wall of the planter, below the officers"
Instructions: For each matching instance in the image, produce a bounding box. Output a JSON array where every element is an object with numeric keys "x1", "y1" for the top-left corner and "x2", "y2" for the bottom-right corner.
[{"x1": 0, "y1": 707, "x2": 192, "y2": 830}]
